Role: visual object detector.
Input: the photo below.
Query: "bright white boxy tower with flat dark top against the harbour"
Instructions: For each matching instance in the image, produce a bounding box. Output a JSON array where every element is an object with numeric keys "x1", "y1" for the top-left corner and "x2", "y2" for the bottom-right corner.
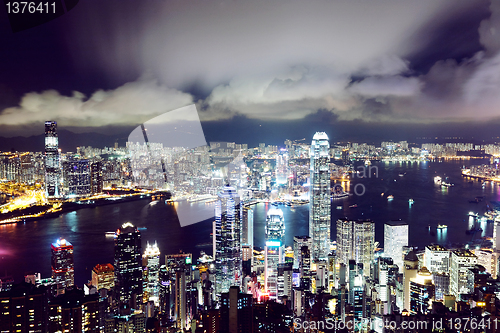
[{"x1": 384, "y1": 221, "x2": 409, "y2": 272}]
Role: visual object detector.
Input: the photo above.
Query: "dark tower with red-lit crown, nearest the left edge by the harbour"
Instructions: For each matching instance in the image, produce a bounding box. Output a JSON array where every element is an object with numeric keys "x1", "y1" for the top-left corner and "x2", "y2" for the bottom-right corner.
[{"x1": 51, "y1": 239, "x2": 75, "y2": 294}]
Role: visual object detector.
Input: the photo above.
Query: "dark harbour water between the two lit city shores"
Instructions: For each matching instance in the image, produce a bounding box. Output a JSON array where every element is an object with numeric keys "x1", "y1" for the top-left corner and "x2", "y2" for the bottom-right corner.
[{"x1": 0, "y1": 160, "x2": 500, "y2": 285}]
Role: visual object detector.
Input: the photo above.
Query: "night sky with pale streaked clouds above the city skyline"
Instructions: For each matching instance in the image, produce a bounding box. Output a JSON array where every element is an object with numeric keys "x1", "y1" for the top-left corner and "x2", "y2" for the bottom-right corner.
[{"x1": 0, "y1": 0, "x2": 500, "y2": 141}]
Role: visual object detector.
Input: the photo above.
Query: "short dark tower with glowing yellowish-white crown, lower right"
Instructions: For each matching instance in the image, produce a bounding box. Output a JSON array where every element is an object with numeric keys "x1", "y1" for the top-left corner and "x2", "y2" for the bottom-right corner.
[{"x1": 410, "y1": 267, "x2": 434, "y2": 314}]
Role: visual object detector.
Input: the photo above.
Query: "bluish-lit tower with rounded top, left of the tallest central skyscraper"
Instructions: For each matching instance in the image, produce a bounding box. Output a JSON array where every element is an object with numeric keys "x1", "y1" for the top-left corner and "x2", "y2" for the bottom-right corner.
[{"x1": 213, "y1": 186, "x2": 241, "y2": 295}]
